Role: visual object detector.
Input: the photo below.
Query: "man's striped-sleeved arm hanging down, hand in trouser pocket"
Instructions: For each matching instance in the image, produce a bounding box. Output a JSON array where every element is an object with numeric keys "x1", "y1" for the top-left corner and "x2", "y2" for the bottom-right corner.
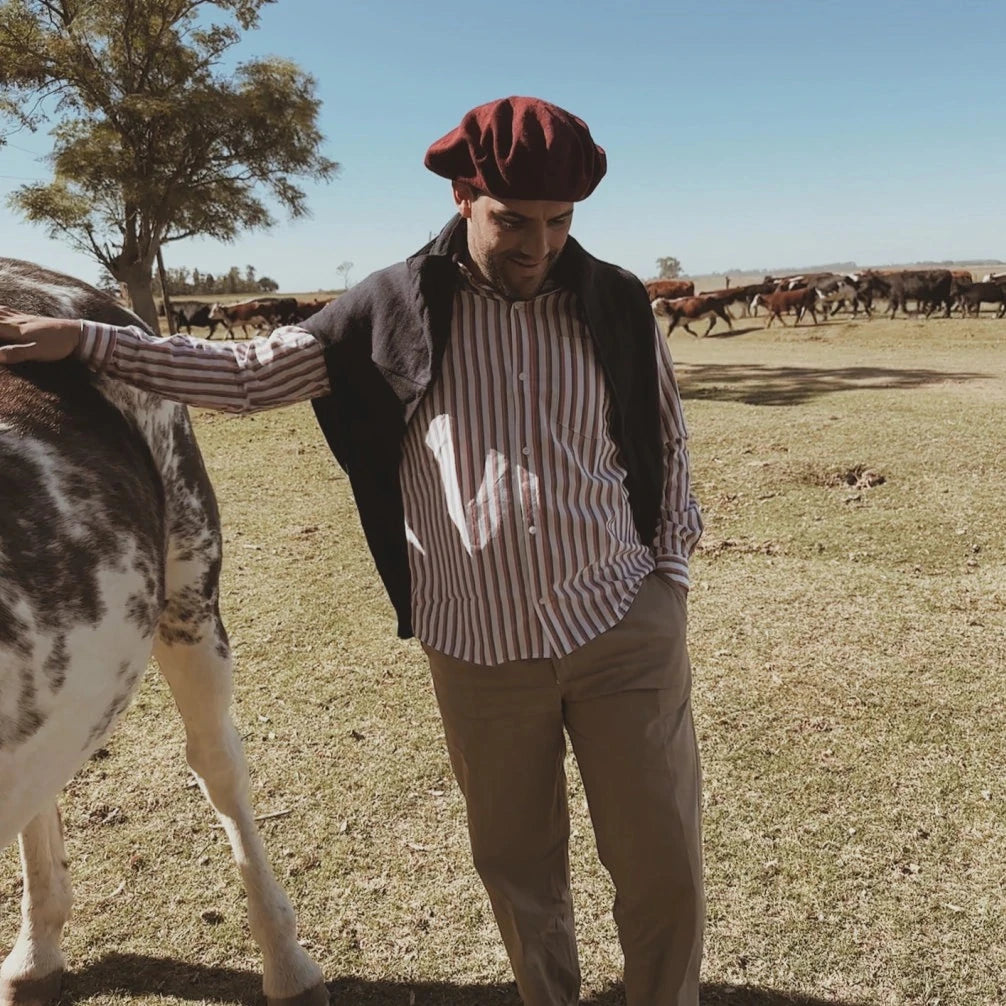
[{"x1": 654, "y1": 326, "x2": 702, "y2": 589}]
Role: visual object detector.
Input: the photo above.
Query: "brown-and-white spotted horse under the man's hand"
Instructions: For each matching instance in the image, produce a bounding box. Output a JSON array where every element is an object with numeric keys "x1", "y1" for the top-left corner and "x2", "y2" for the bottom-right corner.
[{"x1": 0, "y1": 259, "x2": 328, "y2": 1006}]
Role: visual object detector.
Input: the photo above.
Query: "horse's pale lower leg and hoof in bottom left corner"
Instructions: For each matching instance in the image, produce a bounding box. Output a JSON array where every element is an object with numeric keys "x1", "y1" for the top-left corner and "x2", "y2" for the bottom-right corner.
[{"x1": 0, "y1": 803, "x2": 73, "y2": 1006}]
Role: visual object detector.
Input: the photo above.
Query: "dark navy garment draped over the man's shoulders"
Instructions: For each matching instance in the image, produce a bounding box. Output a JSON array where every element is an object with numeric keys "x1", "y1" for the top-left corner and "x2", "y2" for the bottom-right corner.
[{"x1": 304, "y1": 216, "x2": 664, "y2": 639}]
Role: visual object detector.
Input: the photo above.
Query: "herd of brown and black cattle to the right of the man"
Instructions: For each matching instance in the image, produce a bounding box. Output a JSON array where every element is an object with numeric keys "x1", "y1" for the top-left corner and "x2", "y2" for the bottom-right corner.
[{"x1": 646, "y1": 269, "x2": 1006, "y2": 335}]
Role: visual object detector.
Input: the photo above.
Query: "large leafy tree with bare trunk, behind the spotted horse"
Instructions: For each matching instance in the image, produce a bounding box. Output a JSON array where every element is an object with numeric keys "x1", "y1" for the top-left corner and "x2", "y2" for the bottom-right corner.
[{"x1": 0, "y1": 0, "x2": 339, "y2": 326}]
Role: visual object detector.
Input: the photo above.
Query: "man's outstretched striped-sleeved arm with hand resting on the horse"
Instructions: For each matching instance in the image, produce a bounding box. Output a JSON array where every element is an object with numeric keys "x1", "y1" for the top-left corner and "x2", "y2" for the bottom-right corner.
[{"x1": 0, "y1": 308, "x2": 329, "y2": 412}]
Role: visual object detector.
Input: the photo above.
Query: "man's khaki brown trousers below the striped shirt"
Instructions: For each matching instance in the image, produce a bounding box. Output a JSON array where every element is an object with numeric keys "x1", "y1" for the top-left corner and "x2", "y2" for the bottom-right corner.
[{"x1": 427, "y1": 573, "x2": 705, "y2": 1006}]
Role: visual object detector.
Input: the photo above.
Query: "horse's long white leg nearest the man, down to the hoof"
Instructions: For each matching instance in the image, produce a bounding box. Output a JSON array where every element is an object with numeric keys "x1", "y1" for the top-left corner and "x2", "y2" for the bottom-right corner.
[{"x1": 154, "y1": 623, "x2": 329, "y2": 1006}]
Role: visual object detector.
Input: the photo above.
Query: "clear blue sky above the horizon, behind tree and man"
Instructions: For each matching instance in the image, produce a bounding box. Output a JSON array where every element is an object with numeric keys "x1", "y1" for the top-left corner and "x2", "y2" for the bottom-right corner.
[{"x1": 0, "y1": 0, "x2": 1006, "y2": 291}]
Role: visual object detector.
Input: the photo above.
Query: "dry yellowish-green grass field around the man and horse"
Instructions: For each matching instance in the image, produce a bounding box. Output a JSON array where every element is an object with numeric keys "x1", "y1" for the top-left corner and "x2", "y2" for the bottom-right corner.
[{"x1": 0, "y1": 309, "x2": 1006, "y2": 1006}]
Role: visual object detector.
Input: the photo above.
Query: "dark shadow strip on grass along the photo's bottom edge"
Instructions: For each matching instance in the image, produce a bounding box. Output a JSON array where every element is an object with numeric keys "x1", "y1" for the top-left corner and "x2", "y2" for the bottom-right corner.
[{"x1": 59, "y1": 954, "x2": 873, "y2": 1006}]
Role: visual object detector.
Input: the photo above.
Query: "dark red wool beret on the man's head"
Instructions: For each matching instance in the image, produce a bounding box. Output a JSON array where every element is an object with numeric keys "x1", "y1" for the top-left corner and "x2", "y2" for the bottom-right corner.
[{"x1": 424, "y1": 98, "x2": 608, "y2": 202}]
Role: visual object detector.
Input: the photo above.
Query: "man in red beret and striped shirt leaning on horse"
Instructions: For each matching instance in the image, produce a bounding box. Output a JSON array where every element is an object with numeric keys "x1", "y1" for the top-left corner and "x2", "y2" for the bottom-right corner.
[{"x1": 0, "y1": 98, "x2": 704, "y2": 1006}]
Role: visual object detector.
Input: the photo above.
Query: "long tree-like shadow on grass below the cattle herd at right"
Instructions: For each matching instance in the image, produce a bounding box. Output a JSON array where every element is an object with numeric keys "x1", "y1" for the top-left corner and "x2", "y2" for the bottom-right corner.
[{"x1": 677, "y1": 363, "x2": 992, "y2": 405}]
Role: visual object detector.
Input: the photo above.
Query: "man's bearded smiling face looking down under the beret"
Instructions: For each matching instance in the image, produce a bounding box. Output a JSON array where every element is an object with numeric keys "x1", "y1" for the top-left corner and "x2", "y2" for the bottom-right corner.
[{"x1": 454, "y1": 182, "x2": 573, "y2": 301}]
